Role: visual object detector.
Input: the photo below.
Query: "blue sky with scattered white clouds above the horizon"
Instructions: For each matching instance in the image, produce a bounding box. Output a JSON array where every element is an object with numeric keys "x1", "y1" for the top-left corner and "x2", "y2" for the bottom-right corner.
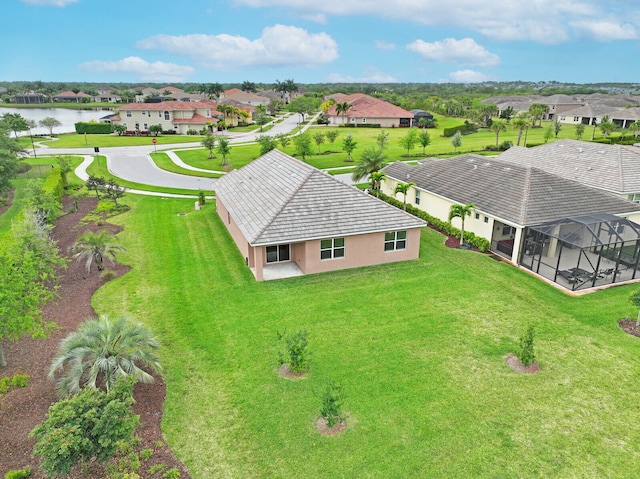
[{"x1": 5, "y1": 0, "x2": 640, "y2": 83}]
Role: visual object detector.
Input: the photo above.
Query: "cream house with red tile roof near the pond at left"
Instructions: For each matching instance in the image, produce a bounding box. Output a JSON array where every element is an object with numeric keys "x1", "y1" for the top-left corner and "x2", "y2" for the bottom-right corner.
[{"x1": 111, "y1": 100, "x2": 219, "y2": 135}]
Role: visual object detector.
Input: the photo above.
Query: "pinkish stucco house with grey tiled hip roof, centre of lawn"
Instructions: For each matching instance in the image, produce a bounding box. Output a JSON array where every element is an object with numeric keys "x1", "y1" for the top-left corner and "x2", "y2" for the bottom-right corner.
[{"x1": 215, "y1": 150, "x2": 426, "y2": 281}]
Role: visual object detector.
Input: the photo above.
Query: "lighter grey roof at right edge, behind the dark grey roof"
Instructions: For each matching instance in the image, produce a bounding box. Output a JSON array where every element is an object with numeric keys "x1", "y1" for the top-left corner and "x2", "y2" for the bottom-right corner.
[{"x1": 498, "y1": 140, "x2": 640, "y2": 194}]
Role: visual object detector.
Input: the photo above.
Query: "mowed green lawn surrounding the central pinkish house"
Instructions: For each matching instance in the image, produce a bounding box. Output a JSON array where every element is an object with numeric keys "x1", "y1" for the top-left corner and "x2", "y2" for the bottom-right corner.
[{"x1": 93, "y1": 195, "x2": 640, "y2": 479}]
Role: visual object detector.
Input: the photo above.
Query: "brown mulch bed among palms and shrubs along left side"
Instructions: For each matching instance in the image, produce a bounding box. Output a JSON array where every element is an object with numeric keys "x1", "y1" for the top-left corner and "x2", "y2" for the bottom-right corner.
[{"x1": 0, "y1": 198, "x2": 190, "y2": 479}]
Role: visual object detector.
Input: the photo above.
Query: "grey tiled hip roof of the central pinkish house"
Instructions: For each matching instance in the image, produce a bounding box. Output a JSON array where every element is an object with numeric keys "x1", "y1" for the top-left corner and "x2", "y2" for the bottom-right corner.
[{"x1": 216, "y1": 150, "x2": 426, "y2": 246}]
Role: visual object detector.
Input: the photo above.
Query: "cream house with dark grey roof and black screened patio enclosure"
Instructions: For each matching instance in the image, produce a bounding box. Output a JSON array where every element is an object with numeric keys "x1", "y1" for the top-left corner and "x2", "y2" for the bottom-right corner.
[{"x1": 382, "y1": 155, "x2": 640, "y2": 290}]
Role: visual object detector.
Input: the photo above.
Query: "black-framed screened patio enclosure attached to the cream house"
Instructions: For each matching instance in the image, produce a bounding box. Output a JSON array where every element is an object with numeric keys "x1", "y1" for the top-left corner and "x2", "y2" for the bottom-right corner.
[{"x1": 519, "y1": 214, "x2": 640, "y2": 291}]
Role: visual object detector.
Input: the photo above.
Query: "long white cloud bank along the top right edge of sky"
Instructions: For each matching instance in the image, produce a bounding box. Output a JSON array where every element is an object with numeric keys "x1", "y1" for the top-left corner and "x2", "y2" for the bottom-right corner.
[{"x1": 231, "y1": 0, "x2": 640, "y2": 44}]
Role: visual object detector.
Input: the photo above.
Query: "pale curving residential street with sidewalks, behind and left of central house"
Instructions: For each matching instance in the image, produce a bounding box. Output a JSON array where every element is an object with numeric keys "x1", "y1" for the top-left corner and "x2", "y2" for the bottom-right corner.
[{"x1": 40, "y1": 114, "x2": 330, "y2": 190}]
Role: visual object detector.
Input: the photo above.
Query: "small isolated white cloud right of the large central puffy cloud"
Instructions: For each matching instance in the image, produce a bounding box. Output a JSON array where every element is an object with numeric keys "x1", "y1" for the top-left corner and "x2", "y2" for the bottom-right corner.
[{"x1": 407, "y1": 38, "x2": 500, "y2": 67}]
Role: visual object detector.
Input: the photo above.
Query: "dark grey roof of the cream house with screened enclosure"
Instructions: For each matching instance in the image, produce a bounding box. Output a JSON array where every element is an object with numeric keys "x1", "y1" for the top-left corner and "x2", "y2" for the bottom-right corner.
[{"x1": 384, "y1": 155, "x2": 640, "y2": 226}]
